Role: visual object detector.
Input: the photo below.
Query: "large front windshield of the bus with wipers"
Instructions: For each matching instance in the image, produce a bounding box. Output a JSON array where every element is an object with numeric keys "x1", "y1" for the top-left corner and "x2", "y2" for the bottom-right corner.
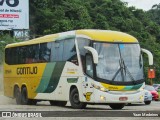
[{"x1": 94, "y1": 42, "x2": 144, "y2": 82}]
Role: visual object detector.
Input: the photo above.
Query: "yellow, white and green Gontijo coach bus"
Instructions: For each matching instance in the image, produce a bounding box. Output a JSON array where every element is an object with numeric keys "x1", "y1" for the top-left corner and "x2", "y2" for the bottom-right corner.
[{"x1": 4, "y1": 29, "x2": 153, "y2": 109}]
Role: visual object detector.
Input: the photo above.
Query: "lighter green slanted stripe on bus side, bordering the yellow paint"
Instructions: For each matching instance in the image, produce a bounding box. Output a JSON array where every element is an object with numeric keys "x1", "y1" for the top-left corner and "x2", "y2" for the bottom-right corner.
[{"x1": 36, "y1": 62, "x2": 56, "y2": 93}]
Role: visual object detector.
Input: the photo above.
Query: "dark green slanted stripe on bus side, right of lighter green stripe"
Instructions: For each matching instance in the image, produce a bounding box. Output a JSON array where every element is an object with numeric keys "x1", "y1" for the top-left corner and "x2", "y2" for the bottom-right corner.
[{"x1": 44, "y1": 62, "x2": 66, "y2": 93}]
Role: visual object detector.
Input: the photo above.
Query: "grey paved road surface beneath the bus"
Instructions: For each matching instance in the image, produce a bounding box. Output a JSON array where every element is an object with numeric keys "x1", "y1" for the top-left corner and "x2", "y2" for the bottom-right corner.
[{"x1": 0, "y1": 92, "x2": 160, "y2": 120}]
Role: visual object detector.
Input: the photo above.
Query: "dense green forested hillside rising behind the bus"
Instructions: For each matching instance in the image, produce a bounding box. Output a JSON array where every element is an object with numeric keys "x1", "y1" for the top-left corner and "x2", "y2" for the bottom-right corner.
[{"x1": 0, "y1": 0, "x2": 160, "y2": 82}]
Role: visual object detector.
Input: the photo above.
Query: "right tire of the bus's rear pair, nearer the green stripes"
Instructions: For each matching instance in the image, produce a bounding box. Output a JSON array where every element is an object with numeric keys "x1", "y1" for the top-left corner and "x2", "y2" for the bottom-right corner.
[{"x1": 21, "y1": 87, "x2": 37, "y2": 105}]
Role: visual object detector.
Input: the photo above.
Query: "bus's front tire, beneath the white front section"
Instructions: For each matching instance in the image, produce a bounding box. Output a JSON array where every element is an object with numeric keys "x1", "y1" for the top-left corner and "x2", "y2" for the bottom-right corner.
[{"x1": 69, "y1": 88, "x2": 87, "y2": 109}]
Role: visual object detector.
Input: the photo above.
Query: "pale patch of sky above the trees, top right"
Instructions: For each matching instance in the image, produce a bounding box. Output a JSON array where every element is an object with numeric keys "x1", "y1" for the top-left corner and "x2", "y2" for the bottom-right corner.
[{"x1": 121, "y1": 0, "x2": 160, "y2": 11}]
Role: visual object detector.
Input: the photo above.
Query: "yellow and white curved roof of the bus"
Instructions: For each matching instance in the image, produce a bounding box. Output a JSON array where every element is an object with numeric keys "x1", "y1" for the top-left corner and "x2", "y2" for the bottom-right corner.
[{"x1": 6, "y1": 29, "x2": 138, "y2": 48}]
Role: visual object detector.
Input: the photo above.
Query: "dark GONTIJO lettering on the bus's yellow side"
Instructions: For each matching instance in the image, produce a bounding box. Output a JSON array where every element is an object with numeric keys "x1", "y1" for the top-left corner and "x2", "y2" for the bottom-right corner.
[{"x1": 17, "y1": 66, "x2": 38, "y2": 75}]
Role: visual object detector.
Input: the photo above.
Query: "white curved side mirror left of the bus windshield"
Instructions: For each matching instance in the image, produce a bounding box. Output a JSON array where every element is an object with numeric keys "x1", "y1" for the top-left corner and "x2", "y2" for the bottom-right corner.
[{"x1": 84, "y1": 46, "x2": 98, "y2": 64}]
